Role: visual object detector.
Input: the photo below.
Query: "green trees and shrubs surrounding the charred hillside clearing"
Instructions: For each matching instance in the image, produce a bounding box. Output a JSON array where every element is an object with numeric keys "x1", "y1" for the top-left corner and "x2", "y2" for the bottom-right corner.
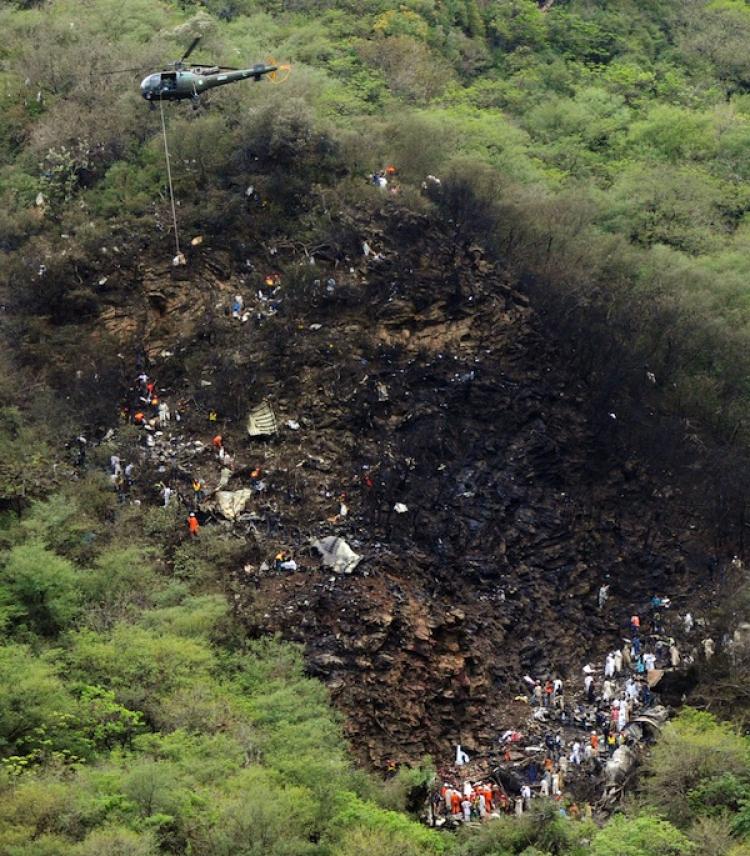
[{"x1": 0, "y1": 0, "x2": 750, "y2": 856}]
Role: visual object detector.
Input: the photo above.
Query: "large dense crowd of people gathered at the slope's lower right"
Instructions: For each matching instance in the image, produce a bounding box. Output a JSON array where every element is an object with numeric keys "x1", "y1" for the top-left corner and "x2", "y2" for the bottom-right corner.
[{"x1": 430, "y1": 590, "x2": 715, "y2": 825}]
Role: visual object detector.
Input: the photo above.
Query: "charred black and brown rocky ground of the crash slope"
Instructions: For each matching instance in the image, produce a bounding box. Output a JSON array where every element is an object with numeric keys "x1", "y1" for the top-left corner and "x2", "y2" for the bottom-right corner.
[{"x1": 45, "y1": 202, "x2": 707, "y2": 766}]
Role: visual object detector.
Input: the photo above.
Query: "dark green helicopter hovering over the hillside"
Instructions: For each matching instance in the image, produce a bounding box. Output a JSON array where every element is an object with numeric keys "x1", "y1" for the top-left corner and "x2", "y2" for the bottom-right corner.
[{"x1": 123, "y1": 36, "x2": 289, "y2": 109}]
